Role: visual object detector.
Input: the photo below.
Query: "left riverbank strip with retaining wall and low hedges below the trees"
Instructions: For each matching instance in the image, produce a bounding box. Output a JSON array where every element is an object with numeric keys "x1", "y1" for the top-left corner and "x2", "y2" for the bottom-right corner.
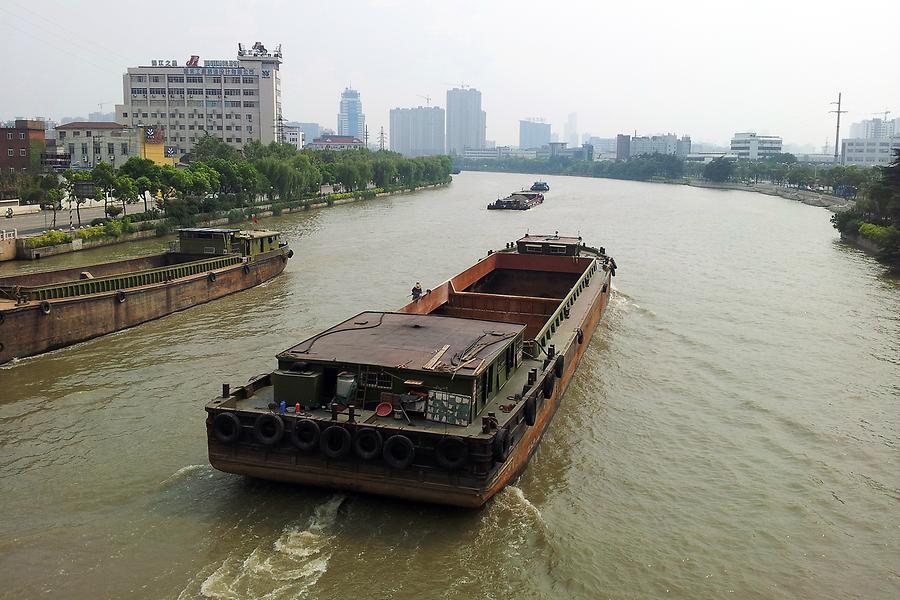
[{"x1": 0, "y1": 180, "x2": 452, "y2": 261}]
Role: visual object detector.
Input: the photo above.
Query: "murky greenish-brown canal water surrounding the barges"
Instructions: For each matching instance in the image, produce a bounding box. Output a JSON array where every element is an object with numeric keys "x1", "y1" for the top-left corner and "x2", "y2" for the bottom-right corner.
[{"x1": 0, "y1": 173, "x2": 900, "y2": 599}]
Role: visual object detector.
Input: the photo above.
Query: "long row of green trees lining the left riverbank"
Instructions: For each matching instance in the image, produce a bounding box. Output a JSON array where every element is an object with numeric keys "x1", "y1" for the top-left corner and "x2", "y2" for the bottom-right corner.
[{"x1": 0, "y1": 136, "x2": 451, "y2": 226}]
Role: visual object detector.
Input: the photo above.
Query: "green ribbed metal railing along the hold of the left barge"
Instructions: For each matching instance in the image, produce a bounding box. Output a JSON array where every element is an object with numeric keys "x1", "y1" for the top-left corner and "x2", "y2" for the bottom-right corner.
[{"x1": 0, "y1": 254, "x2": 243, "y2": 302}]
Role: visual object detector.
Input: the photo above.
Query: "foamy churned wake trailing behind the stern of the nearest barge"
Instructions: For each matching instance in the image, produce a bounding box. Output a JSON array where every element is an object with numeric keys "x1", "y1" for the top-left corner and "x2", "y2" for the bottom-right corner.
[{"x1": 190, "y1": 495, "x2": 346, "y2": 600}]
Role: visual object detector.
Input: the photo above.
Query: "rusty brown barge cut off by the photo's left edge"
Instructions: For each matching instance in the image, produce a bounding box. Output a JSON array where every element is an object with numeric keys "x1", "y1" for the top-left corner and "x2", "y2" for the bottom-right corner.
[{"x1": 0, "y1": 228, "x2": 293, "y2": 364}]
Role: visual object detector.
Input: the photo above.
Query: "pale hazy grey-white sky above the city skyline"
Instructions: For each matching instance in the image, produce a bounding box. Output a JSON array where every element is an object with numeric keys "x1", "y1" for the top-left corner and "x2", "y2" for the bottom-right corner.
[{"x1": 0, "y1": 0, "x2": 900, "y2": 147}]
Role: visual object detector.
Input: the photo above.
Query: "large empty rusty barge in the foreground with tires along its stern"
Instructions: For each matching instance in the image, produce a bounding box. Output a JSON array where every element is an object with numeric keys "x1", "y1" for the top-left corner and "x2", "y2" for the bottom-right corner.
[{"x1": 206, "y1": 235, "x2": 616, "y2": 507}]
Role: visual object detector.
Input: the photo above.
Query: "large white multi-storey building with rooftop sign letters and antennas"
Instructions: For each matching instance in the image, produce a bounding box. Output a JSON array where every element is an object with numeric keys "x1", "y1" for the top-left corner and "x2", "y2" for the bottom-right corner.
[{"x1": 116, "y1": 42, "x2": 282, "y2": 157}]
